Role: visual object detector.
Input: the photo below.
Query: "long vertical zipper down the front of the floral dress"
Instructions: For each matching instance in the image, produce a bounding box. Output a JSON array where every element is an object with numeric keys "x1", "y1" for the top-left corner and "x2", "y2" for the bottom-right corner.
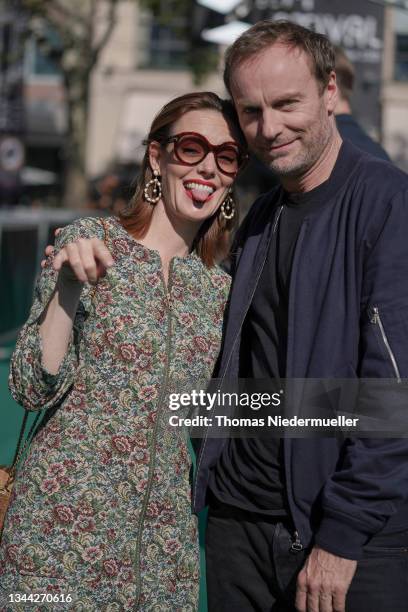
[{"x1": 134, "y1": 260, "x2": 173, "y2": 609}]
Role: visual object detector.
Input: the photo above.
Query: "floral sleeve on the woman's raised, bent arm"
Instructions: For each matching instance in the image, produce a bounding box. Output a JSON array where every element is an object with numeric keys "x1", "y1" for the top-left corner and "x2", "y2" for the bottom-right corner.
[{"x1": 9, "y1": 218, "x2": 103, "y2": 410}]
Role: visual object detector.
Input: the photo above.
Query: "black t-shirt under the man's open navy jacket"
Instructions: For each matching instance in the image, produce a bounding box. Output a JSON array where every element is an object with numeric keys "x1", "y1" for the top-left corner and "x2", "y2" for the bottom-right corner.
[{"x1": 209, "y1": 166, "x2": 341, "y2": 516}]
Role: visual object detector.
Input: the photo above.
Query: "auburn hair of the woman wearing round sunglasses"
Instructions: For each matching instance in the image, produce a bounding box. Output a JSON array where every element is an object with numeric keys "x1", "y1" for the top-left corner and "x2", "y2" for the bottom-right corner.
[{"x1": 119, "y1": 91, "x2": 246, "y2": 267}]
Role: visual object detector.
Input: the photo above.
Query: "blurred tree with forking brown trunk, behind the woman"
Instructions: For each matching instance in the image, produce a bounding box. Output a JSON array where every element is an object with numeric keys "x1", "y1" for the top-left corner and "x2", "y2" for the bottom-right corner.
[{"x1": 21, "y1": 0, "x2": 216, "y2": 208}]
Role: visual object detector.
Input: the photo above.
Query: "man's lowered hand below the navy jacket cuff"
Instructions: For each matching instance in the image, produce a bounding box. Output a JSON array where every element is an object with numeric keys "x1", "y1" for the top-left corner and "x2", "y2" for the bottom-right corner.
[{"x1": 296, "y1": 546, "x2": 357, "y2": 612}]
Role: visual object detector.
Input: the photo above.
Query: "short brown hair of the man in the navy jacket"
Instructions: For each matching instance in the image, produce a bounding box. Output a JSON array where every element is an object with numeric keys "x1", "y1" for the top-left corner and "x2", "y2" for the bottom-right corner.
[{"x1": 224, "y1": 19, "x2": 335, "y2": 95}]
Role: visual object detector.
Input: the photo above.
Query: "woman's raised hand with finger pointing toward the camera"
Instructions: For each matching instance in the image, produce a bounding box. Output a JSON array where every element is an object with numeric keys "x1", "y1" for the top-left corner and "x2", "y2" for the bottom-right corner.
[{"x1": 53, "y1": 238, "x2": 115, "y2": 285}]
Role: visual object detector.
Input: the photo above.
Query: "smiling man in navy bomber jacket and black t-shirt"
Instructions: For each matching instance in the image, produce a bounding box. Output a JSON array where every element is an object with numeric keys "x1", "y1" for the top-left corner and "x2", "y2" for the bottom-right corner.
[{"x1": 193, "y1": 21, "x2": 408, "y2": 612}]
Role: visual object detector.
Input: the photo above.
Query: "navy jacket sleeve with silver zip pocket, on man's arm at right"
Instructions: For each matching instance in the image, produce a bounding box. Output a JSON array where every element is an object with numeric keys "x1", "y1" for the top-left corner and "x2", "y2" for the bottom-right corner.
[{"x1": 315, "y1": 192, "x2": 408, "y2": 559}]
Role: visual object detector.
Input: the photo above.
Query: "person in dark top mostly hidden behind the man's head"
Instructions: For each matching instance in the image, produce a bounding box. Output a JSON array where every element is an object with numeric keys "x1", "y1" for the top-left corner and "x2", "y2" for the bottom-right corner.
[{"x1": 334, "y1": 47, "x2": 390, "y2": 161}]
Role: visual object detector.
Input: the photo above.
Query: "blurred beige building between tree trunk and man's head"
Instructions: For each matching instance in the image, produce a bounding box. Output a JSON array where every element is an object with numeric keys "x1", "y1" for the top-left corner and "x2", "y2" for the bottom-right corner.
[{"x1": 87, "y1": 1, "x2": 223, "y2": 176}]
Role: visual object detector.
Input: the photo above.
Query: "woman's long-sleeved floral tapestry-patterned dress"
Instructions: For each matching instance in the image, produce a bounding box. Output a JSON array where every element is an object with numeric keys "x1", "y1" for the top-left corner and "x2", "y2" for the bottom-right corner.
[{"x1": 0, "y1": 217, "x2": 230, "y2": 612}]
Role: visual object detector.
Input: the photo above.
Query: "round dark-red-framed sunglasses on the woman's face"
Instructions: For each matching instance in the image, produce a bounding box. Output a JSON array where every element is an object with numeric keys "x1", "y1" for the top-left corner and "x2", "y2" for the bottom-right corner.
[{"x1": 162, "y1": 132, "x2": 248, "y2": 176}]
